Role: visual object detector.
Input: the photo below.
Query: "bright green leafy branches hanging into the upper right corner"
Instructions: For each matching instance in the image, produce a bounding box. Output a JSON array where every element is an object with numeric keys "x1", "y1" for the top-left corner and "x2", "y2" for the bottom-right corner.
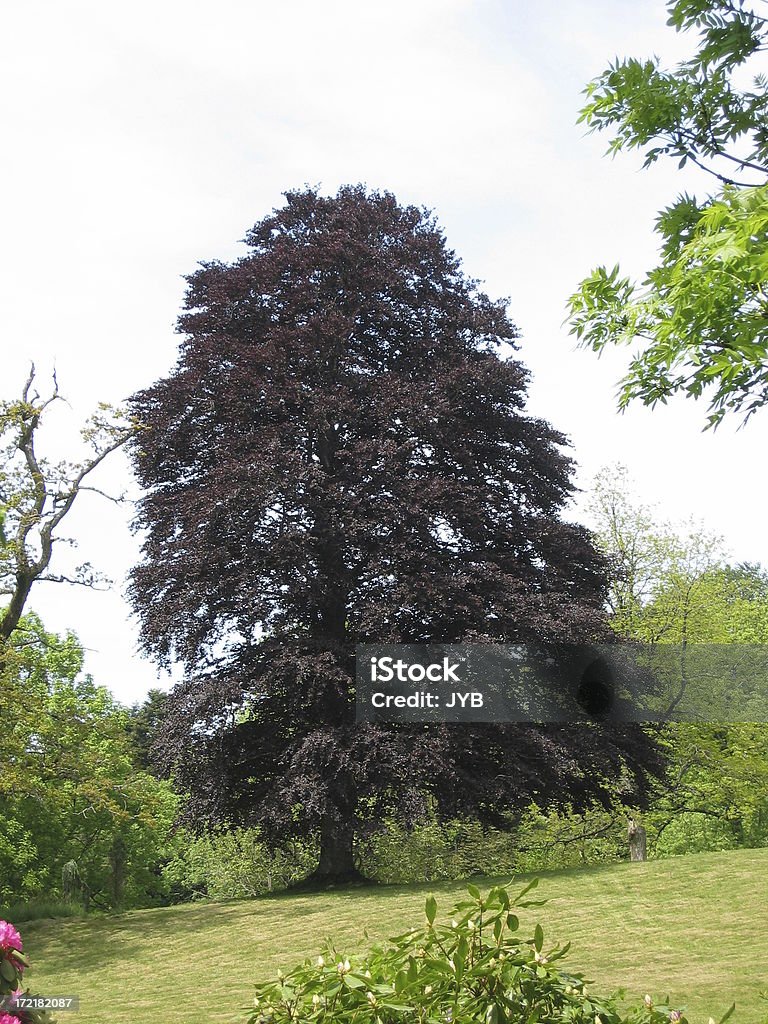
[{"x1": 569, "y1": 0, "x2": 768, "y2": 426}]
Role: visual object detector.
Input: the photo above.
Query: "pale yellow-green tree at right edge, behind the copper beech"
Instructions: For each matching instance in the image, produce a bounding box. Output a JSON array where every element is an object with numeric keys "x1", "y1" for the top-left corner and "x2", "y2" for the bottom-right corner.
[{"x1": 591, "y1": 467, "x2": 768, "y2": 853}]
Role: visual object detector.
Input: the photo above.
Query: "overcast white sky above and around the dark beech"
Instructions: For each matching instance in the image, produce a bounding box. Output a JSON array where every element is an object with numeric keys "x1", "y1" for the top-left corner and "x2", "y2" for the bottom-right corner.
[{"x1": 0, "y1": 0, "x2": 768, "y2": 701}]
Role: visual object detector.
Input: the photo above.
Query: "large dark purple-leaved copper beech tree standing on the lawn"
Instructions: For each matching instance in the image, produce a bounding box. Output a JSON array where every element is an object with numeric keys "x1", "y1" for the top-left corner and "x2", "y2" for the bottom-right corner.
[{"x1": 132, "y1": 185, "x2": 655, "y2": 879}]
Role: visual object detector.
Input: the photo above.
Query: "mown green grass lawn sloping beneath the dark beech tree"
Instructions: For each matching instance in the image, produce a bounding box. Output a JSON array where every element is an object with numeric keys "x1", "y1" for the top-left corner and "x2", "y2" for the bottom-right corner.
[{"x1": 16, "y1": 850, "x2": 768, "y2": 1024}]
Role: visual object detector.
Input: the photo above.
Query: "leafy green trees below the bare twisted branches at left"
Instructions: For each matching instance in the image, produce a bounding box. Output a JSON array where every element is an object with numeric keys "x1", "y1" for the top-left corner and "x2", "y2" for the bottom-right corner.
[{"x1": 0, "y1": 612, "x2": 177, "y2": 906}]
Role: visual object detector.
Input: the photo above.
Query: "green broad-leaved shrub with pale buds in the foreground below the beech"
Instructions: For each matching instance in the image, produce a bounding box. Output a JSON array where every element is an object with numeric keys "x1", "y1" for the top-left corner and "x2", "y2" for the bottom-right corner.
[{"x1": 248, "y1": 881, "x2": 733, "y2": 1024}]
